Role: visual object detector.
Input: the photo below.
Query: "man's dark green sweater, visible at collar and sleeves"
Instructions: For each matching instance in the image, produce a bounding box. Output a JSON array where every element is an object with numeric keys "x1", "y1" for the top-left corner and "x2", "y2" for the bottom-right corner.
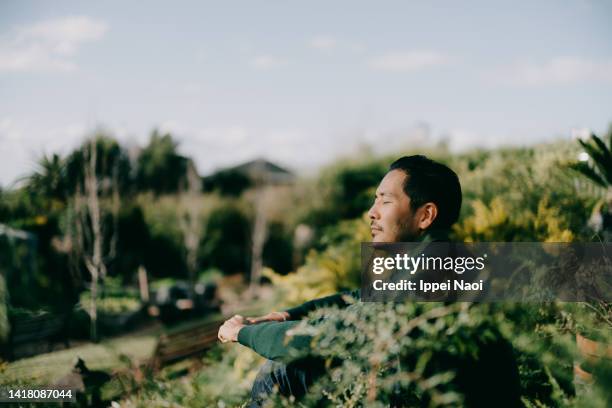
[{"x1": 238, "y1": 230, "x2": 448, "y2": 360}]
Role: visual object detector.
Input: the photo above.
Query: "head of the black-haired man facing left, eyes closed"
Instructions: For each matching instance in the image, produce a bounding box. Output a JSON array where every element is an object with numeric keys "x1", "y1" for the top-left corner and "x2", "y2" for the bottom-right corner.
[{"x1": 368, "y1": 155, "x2": 461, "y2": 242}]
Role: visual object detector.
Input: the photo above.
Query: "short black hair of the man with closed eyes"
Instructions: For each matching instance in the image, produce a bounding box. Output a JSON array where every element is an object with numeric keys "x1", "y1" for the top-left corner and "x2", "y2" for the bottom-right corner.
[{"x1": 389, "y1": 155, "x2": 462, "y2": 228}]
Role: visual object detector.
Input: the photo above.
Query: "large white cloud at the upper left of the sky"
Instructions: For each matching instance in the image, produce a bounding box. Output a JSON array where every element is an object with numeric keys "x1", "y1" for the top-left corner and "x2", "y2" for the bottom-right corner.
[{"x1": 0, "y1": 16, "x2": 108, "y2": 72}]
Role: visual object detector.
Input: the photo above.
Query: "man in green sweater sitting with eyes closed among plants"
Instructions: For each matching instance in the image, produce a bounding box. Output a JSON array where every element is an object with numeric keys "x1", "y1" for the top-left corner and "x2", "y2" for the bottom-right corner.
[{"x1": 219, "y1": 155, "x2": 461, "y2": 406}]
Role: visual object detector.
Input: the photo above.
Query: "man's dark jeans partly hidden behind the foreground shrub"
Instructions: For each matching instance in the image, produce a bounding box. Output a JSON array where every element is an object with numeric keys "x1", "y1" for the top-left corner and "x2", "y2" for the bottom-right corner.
[{"x1": 247, "y1": 359, "x2": 324, "y2": 408}]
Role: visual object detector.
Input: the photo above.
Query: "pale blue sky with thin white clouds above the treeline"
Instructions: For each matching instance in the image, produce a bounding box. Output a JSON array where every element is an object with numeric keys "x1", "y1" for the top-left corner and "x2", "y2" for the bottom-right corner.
[{"x1": 0, "y1": 0, "x2": 612, "y2": 187}]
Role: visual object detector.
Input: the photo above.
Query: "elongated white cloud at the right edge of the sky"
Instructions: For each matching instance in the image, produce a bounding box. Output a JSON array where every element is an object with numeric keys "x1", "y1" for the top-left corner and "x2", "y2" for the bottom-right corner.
[{"x1": 495, "y1": 57, "x2": 612, "y2": 85}]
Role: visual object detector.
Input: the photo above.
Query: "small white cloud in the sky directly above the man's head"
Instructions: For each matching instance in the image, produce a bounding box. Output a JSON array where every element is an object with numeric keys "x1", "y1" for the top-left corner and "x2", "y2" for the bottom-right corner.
[{"x1": 368, "y1": 51, "x2": 449, "y2": 72}]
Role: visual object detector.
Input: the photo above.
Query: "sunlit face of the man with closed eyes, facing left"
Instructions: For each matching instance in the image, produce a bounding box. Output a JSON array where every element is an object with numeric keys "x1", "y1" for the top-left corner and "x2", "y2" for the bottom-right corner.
[{"x1": 368, "y1": 170, "x2": 419, "y2": 242}]
